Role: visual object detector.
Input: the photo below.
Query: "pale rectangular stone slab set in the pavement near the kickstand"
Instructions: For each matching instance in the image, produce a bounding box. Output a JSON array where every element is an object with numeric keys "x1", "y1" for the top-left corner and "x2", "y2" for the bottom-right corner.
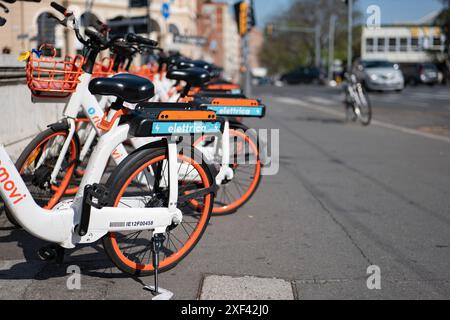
[{"x1": 200, "y1": 275, "x2": 294, "y2": 300}]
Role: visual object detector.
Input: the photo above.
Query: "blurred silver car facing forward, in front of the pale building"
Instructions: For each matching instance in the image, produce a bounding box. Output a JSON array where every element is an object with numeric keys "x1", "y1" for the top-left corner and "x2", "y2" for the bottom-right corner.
[{"x1": 353, "y1": 60, "x2": 405, "y2": 91}]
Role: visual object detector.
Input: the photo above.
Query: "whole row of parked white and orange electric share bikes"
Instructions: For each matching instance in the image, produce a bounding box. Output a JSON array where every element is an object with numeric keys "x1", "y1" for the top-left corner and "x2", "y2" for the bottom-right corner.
[{"x1": 0, "y1": 2, "x2": 265, "y2": 293}]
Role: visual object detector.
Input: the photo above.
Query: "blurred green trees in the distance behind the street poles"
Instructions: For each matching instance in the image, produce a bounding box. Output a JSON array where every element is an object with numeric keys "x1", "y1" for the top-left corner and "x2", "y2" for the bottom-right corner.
[{"x1": 260, "y1": 0, "x2": 361, "y2": 74}]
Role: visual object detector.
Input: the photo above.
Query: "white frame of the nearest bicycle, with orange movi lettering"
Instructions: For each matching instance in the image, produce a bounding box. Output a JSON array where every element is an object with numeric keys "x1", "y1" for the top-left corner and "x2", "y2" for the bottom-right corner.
[{"x1": 0, "y1": 105, "x2": 182, "y2": 248}]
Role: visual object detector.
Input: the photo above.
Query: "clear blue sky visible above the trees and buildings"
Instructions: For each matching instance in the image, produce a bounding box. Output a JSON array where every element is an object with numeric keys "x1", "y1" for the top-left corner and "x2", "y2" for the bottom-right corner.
[{"x1": 254, "y1": 0, "x2": 442, "y2": 26}]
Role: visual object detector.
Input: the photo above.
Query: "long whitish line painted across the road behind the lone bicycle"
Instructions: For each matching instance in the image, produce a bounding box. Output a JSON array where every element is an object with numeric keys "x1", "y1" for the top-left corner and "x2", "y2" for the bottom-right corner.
[{"x1": 274, "y1": 97, "x2": 450, "y2": 143}]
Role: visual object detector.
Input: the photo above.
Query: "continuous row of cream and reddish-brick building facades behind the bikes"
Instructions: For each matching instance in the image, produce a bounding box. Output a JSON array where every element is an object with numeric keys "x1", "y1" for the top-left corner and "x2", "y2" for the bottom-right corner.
[{"x1": 0, "y1": 0, "x2": 241, "y2": 80}]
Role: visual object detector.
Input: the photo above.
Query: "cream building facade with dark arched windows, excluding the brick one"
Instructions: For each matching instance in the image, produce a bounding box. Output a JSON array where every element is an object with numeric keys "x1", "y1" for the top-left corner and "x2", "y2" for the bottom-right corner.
[{"x1": 0, "y1": 0, "x2": 201, "y2": 56}]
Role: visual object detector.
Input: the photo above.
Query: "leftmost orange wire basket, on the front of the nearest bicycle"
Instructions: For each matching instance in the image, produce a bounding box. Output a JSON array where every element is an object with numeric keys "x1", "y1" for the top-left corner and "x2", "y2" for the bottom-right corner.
[{"x1": 26, "y1": 44, "x2": 84, "y2": 99}]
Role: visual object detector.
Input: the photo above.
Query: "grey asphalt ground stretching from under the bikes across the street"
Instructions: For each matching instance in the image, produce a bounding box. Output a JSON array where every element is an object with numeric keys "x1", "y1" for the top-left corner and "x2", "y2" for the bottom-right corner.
[{"x1": 0, "y1": 86, "x2": 450, "y2": 299}]
